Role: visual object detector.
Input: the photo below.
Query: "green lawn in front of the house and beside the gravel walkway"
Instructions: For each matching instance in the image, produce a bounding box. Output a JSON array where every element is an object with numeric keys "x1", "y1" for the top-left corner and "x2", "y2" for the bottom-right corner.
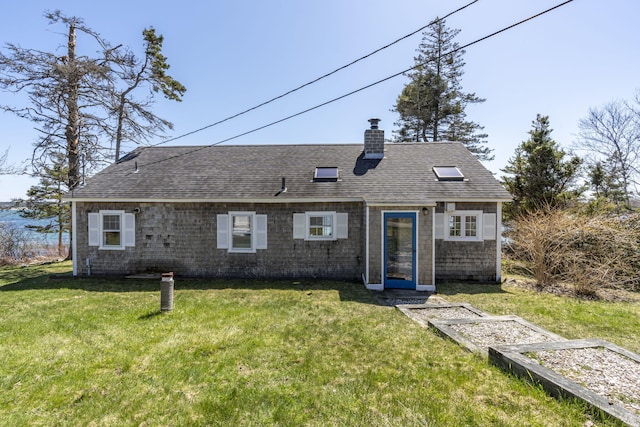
[{"x1": 0, "y1": 263, "x2": 639, "y2": 426}]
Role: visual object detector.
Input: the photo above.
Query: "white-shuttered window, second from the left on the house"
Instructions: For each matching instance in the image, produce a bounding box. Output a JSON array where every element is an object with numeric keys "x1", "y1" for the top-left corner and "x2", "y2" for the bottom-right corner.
[{"x1": 216, "y1": 212, "x2": 267, "y2": 253}]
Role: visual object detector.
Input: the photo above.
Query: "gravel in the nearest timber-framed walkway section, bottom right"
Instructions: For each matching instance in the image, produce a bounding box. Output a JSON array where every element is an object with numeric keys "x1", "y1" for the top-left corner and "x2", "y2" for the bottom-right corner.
[{"x1": 533, "y1": 348, "x2": 640, "y2": 414}]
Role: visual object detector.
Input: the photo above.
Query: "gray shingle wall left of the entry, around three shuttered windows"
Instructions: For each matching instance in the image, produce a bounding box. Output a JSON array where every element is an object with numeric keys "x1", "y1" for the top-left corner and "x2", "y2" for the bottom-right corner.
[{"x1": 76, "y1": 202, "x2": 364, "y2": 280}]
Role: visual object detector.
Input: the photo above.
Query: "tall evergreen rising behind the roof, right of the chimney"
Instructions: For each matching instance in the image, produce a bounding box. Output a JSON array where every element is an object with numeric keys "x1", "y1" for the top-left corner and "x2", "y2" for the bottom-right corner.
[{"x1": 393, "y1": 20, "x2": 494, "y2": 160}]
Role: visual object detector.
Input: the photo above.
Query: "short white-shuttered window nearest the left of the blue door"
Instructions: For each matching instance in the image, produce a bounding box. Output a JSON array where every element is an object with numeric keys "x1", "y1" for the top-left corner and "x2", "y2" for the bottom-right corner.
[{"x1": 293, "y1": 212, "x2": 349, "y2": 240}]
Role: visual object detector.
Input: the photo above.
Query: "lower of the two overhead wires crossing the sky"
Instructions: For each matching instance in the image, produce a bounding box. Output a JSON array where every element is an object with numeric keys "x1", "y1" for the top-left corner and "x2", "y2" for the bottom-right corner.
[{"x1": 141, "y1": 0, "x2": 573, "y2": 171}]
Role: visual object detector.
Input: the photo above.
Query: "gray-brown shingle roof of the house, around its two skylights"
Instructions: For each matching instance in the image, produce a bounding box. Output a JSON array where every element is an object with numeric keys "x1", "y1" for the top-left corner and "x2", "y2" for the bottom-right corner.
[{"x1": 67, "y1": 142, "x2": 511, "y2": 203}]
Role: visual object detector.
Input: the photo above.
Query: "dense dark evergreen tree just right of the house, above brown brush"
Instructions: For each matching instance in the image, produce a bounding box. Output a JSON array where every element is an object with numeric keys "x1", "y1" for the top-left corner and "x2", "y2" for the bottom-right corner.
[{"x1": 502, "y1": 114, "x2": 582, "y2": 217}]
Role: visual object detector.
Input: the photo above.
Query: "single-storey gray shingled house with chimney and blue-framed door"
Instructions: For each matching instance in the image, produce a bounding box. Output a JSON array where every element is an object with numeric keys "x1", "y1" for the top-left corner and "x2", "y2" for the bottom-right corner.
[{"x1": 66, "y1": 119, "x2": 511, "y2": 290}]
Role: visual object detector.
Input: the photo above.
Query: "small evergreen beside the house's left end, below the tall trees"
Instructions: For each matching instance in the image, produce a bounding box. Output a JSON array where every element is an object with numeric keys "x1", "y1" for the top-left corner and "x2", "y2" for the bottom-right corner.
[{"x1": 20, "y1": 153, "x2": 71, "y2": 255}]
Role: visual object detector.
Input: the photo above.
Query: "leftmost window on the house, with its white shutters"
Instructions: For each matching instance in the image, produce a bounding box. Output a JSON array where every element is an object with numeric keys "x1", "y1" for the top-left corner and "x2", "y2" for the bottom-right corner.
[{"x1": 88, "y1": 210, "x2": 136, "y2": 250}]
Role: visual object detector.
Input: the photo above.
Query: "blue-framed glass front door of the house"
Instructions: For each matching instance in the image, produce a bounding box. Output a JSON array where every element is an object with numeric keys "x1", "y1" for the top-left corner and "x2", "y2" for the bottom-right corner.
[{"x1": 384, "y1": 212, "x2": 416, "y2": 289}]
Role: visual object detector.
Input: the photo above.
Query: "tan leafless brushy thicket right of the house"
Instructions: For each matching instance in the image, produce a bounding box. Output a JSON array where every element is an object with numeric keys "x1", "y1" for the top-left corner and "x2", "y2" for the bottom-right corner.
[{"x1": 508, "y1": 210, "x2": 640, "y2": 295}]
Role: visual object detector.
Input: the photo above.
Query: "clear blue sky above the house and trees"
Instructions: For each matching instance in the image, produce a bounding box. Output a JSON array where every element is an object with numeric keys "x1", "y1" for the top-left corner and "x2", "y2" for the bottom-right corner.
[{"x1": 0, "y1": 0, "x2": 640, "y2": 201}]
